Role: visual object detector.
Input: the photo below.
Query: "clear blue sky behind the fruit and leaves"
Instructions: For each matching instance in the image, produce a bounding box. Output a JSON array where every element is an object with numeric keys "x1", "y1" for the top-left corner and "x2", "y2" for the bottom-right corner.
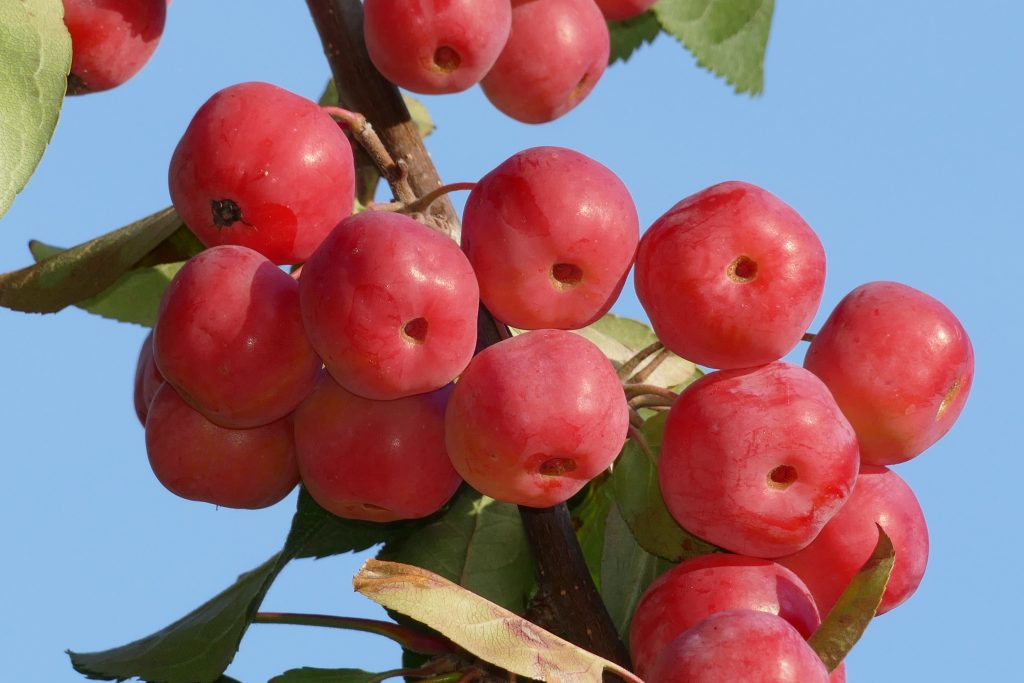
[{"x1": 0, "y1": 0, "x2": 1024, "y2": 683}]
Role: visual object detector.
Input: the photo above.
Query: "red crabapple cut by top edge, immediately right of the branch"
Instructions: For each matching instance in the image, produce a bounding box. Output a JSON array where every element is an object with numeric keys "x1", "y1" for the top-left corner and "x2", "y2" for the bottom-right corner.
[{"x1": 362, "y1": 0, "x2": 512, "y2": 95}]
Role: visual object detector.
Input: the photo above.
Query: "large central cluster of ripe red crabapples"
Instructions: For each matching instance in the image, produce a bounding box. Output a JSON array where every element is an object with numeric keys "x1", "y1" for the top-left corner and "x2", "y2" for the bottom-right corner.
[{"x1": 128, "y1": 83, "x2": 974, "y2": 681}]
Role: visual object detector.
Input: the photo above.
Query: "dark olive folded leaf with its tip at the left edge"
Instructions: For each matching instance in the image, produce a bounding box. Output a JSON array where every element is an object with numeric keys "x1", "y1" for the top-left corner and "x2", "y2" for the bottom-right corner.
[{"x1": 0, "y1": 209, "x2": 181, "y2": 313}]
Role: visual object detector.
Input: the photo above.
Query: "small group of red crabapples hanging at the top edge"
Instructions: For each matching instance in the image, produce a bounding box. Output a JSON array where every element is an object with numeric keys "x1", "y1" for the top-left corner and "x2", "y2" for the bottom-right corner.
[{"x1": 364, "y1": 0, "x2": 654, "y2": 123}]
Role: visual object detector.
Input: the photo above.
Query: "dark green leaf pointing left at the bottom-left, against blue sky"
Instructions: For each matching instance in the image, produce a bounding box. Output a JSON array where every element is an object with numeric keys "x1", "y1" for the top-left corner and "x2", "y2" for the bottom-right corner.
[{"x1": 68, "y1": 553, "x2": 288, "y2": 683}]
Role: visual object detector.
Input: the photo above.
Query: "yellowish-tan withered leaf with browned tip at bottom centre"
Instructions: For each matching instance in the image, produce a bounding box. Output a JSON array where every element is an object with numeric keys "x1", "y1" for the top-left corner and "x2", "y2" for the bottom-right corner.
[{"x1": 352, "y1": 560, "x2": 639, "y2": 683}]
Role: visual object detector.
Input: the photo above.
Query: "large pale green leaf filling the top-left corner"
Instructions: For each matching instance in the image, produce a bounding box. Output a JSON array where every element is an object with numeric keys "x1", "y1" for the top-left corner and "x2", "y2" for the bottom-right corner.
[{"x1": 0, "y1": 0, "x2": 71, "y2": 216}]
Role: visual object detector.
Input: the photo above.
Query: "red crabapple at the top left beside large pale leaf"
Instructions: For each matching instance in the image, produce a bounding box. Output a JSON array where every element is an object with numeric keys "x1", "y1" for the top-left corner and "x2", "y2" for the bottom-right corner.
[{"x1": 63, "y1": 0, "x2": 167, "y2": 95}]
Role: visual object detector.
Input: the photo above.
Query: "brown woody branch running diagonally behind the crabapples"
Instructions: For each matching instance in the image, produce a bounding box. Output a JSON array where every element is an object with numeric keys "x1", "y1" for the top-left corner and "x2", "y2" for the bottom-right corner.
[{"x1": 306, "y1": 0, "x2": 630, "y2": 668}]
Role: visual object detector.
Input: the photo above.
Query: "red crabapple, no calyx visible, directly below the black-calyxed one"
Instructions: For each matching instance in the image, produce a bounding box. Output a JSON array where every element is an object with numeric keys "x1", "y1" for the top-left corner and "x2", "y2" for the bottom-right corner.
[{"x1": 153, "y1": 246, "x2": 321, "y2": 429}]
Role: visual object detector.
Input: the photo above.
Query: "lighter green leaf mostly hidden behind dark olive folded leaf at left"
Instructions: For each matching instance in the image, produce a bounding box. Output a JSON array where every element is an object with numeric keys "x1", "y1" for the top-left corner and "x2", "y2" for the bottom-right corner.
[{"x1": 29, "y1": 240, "x2": 184, "y2": 328}]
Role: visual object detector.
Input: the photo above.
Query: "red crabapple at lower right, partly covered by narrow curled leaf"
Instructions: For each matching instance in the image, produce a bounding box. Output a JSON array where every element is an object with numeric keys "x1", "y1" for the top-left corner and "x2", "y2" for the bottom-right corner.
[{"x1": 778, "y1": 465, "x2": 929, "y2": 614}]
